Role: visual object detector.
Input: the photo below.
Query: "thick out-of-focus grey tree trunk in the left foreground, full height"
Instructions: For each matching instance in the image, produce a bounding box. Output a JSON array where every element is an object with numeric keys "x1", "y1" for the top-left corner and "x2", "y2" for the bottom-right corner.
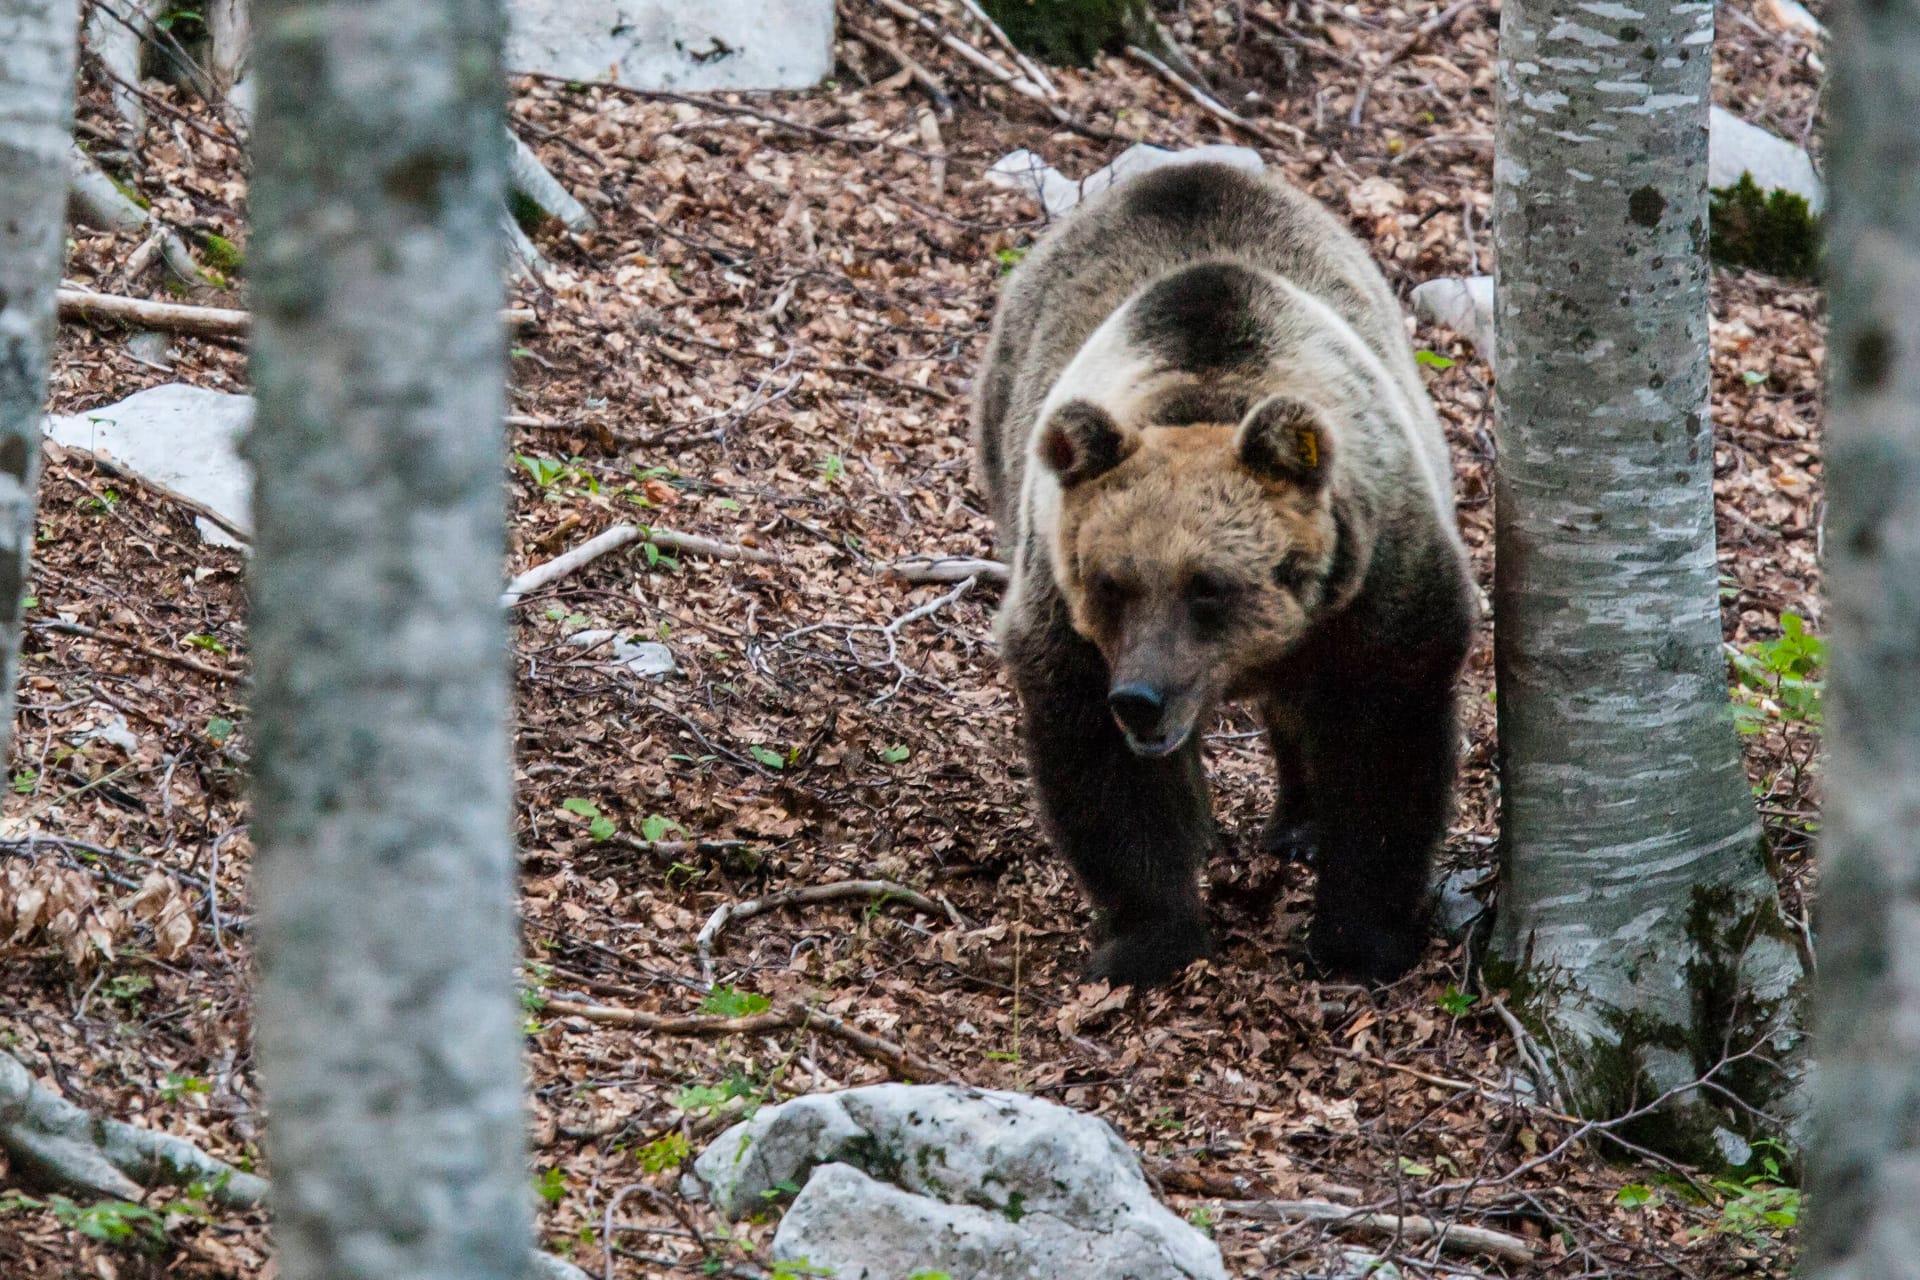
[{"x1": 252, "y1": 0, "x2": 530, "y2": 1280}]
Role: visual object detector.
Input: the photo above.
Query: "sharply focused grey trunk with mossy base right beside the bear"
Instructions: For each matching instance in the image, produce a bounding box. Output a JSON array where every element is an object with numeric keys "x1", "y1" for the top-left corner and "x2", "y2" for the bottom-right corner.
[{"x1": 1488, "y1": 0, "x2": 1803, "y2": 1155}]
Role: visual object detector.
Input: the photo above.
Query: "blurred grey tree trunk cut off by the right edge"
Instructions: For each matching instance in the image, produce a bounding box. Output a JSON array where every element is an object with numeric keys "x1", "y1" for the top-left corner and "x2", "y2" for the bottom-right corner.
[{"x1": 1801, "y1": 0, "x2": 1920, "y2": 1280}]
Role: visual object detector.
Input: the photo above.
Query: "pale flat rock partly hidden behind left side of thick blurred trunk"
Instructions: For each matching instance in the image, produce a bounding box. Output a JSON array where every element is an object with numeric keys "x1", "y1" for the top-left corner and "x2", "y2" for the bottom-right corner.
[{"x1": 44, "y1": 382, "x2": 253, "y2": 547}]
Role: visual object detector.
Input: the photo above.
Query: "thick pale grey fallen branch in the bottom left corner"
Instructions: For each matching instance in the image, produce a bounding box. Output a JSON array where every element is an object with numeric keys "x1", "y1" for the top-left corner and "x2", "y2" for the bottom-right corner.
[{"x1": 0, "y1": 1054, "x2": 267, "y2": 1209}]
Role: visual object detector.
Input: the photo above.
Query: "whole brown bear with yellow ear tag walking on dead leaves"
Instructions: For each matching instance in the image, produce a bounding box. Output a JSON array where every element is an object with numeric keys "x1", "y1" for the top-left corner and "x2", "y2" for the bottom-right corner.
[{"x1": 975, "y1": 163, "x2": 1475, "y2": 984}]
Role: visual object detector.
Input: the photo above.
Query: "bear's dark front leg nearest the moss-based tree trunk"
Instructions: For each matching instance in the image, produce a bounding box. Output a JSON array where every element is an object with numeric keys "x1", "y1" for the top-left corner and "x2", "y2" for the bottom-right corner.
[{"x1": 1308, "y1": 670, "x2": 1459, "y2": 983}]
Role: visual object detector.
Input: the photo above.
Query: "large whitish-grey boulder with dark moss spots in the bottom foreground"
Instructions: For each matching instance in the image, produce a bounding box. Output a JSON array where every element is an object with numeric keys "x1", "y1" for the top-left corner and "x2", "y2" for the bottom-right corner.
[{"x1": 689, "y1": 1084, "x2": 1227, "y2": 1280}]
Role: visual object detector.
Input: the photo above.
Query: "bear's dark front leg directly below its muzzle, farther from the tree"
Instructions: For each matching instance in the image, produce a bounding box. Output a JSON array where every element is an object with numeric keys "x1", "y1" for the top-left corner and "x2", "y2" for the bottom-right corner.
[{"x1": 1006, "y1": 606, "x2": 1213, "y2": 986}]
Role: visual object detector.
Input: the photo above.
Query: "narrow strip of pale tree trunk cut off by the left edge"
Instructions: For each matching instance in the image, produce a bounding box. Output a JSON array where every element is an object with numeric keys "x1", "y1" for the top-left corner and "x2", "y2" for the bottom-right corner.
[{"x1": 0, "y1": 0, "x2": 79, "y2": 760}]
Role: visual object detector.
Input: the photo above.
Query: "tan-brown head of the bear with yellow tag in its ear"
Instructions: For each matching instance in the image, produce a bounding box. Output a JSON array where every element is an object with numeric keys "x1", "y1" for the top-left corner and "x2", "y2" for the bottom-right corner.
[{"x1": 1035, "y1": 395, "x2": 1344, "y2": 756}]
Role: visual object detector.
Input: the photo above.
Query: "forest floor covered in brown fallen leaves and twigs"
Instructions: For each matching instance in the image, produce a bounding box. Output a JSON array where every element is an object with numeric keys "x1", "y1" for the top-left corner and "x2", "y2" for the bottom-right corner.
[{"x1": 0, "y1": 0, "x2": 1822, "y2": 1280}]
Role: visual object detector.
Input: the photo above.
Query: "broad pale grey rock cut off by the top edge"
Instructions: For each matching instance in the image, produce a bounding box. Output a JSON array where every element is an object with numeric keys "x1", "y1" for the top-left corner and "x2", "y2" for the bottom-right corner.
[{"x1": 507, "y1": 0, "x2": 833, "y2": 92}]
